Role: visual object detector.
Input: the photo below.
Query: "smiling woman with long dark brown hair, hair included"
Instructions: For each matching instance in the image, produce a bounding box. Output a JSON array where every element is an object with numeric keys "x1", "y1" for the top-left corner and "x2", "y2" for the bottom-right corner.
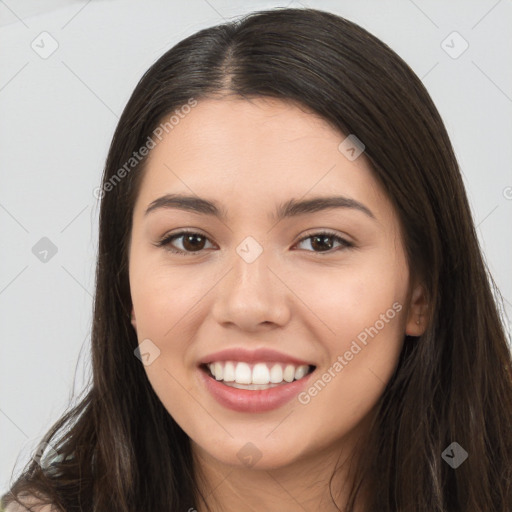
[{"x1": 4, "y1": 9, "x2": 512, "y2": 512}]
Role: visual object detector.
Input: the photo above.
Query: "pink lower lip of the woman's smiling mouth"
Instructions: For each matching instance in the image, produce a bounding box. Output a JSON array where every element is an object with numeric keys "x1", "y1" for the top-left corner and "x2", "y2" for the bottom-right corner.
[{"x1": 199, "y1": 369, "x2": 314, "y2": 413}]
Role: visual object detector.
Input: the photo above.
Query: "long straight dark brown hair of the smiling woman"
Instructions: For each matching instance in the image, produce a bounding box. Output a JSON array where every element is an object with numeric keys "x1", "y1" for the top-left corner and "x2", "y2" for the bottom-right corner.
[{"x1": 3, "y1": 9, "x2": 512, "y2": 512}]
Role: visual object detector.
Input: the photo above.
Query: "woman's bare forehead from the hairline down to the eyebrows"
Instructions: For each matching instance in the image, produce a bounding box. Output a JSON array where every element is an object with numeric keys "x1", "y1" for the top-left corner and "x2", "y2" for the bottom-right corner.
[{"x1": 138, "y1": 98, "x2": 389, "y2": 224}]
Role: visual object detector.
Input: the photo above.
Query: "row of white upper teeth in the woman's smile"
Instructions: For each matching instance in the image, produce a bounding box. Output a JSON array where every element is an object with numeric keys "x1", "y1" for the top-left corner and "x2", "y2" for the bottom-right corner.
[{"x1": 208, "y1": 361, "x2": 309, "y2": 384}]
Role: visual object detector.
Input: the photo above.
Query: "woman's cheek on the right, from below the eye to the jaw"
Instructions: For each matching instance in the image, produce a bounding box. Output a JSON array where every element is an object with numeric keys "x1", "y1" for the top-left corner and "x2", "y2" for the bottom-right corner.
[{"x1": 292, "y1": 254, "x2": 407, "y2": 416}]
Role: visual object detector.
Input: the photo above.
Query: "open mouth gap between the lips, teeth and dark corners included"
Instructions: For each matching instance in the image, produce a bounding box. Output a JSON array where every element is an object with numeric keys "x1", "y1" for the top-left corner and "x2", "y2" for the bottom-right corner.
[{"x1": 201, "y1": 361, "x2": 316, "y2": 390}]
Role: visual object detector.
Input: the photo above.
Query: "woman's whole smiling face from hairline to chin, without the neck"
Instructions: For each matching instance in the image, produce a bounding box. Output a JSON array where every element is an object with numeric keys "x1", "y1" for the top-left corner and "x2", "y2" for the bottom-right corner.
[{"x1": 129, "y1": 98, "x2": 423, "y2": 468}]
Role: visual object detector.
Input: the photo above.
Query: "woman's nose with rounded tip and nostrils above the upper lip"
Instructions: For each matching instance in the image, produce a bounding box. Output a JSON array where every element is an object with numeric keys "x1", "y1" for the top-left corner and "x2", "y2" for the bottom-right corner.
[{"x1": 212, "y1": 247, "x2": 292, "y2": 332}]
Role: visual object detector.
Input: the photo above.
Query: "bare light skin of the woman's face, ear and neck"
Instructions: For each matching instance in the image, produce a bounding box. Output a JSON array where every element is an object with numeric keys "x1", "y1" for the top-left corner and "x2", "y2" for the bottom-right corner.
[{"x1": 129, "y1": 97, "x2": 425, "y2": 512}]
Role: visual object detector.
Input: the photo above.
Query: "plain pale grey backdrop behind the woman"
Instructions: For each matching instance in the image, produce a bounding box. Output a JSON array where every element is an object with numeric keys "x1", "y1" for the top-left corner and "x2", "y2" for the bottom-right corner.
[{"x1": 0, "y1": 0, "x2": 512, "y2": 492}]
